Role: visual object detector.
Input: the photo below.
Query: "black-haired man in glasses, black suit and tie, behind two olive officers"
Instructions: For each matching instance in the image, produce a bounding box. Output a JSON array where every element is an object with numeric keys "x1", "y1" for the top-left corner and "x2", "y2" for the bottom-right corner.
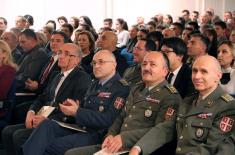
[{"x1": 161, "y1": 37, "x2": 195, "y2": 98}]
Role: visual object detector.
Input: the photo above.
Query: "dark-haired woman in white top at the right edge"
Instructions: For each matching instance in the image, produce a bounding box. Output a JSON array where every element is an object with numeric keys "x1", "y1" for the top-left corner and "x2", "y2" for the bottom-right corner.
[{"x1": 217, "y1": 41, "x2": 235, "y2": 95}]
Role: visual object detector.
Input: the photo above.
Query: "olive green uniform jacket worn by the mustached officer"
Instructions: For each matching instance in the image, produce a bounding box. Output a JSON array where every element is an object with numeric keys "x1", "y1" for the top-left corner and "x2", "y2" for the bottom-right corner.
[{"x1": 66, "y1": 81, "x2": 181, "y2": 155}]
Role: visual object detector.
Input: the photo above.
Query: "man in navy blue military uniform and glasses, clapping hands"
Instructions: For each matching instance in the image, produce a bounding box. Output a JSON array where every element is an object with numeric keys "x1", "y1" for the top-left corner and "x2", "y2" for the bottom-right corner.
[{"x1": 23, "y1": 50, "x2": 129, "y2": 155}]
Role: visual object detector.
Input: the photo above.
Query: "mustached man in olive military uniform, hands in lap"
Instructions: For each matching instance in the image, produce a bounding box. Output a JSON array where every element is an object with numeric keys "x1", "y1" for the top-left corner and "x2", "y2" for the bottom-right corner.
[{"x1": 66, "y1": 51, "x2": 181, "y2": 155}]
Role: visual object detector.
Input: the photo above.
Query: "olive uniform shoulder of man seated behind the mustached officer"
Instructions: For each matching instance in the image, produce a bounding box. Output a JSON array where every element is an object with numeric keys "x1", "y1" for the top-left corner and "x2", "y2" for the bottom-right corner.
[{"x1": 123, "y1": 64, "x2": 142, "y2": 86}]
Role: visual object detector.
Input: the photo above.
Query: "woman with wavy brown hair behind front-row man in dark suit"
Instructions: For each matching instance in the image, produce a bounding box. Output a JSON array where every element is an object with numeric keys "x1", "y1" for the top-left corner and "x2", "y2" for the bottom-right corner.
[{"x1": 74, "y1": 30, "x2": 95, "y2": 74}]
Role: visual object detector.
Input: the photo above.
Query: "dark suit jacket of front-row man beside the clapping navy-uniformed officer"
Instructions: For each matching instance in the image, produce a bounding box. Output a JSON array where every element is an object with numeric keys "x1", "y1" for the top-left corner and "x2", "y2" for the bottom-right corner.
[{"x1": 30, "y1": 67, "x2": 91, "y2": 112}]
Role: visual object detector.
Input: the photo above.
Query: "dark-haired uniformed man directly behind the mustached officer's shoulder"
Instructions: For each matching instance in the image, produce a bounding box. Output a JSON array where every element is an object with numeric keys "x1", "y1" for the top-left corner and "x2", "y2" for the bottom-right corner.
[{"x1": 123, "y1": 39, "x2": 156, "y2": 86}]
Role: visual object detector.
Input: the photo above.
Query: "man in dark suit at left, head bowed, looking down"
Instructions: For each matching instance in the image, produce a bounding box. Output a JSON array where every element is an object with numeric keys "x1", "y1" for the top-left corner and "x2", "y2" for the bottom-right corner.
[{"x1": 16, "y1": 29, "x2": 49, "y2": 92}]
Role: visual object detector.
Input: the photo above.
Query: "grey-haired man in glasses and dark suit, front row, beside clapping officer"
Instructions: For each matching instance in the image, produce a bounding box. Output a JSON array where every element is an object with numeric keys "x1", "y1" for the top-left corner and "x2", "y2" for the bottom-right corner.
[{"x1": 2, "y1": 43, "x2": 91, "y2": 155}]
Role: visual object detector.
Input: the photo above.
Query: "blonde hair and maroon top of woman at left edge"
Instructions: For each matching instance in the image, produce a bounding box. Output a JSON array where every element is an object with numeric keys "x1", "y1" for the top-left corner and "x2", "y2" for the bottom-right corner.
[{"x1": 0, "y1": 40, "x2": 17, "y2": 100}]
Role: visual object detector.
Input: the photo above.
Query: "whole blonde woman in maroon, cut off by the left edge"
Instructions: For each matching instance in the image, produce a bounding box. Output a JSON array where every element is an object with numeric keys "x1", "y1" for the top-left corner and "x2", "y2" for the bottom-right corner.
[{"x1": 0, "y1": 40, "x2": 17, "y2": 131}]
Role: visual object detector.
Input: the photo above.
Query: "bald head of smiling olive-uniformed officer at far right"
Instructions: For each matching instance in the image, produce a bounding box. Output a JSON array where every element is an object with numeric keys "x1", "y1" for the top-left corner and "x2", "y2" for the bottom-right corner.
[{"x1": 192, "y1": 55, "x2": 222, "y2": 96}]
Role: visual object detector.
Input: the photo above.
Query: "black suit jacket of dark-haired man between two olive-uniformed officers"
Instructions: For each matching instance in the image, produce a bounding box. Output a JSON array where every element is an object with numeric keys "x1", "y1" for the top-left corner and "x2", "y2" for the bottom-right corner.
[{"x1": 173, "y1": 64, "x2": 195, "y2": 98}]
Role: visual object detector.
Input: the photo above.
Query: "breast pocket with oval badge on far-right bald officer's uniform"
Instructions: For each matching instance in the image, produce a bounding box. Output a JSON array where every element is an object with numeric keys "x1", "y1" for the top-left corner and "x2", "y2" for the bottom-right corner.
[{"x1": 189, "y1": 119, "x2": 212, "y2": 142}]
